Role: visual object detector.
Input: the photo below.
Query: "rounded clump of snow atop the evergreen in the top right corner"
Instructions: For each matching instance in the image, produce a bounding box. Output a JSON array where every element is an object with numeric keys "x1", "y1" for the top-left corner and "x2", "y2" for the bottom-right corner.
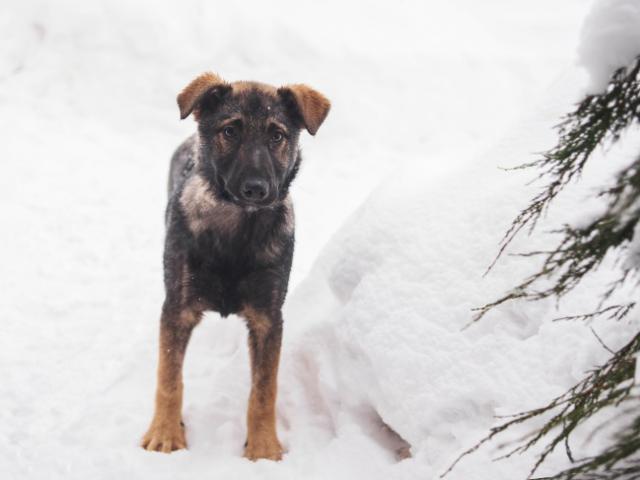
[{"x1": 578, "y1": 0, "x2": 640, "y2": 93}]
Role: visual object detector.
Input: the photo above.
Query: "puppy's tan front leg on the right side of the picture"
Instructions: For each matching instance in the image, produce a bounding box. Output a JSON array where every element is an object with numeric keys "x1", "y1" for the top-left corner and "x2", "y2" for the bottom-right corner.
[{"x1": 243, "y1": 307, "x2": 282, "y2": 460}]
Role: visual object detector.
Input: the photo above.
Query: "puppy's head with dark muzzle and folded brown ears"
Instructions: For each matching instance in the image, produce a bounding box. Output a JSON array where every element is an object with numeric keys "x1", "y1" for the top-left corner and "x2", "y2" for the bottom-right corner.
[{"x1": 178, "y1": 73, "x2": 330, "y2": 208}]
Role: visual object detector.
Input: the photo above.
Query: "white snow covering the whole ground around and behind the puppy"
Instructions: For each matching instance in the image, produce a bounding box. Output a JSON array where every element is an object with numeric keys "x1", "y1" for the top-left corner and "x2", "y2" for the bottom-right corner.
[{"x1": 0, "y1": 0, "x2": 640, "y2": 480}]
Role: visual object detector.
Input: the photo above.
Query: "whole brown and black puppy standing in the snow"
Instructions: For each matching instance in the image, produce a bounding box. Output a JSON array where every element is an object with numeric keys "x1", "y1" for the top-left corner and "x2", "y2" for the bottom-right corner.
[{"x1": 142, "y1": 73, "x2": 330, "y2": 460}]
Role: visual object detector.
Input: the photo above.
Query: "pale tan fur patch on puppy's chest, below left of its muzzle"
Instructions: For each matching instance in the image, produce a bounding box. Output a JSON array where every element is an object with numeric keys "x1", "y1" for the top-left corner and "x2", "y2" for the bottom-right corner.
[{"x1": 180, "y1": 175, "x2": 242, "y2": 235}]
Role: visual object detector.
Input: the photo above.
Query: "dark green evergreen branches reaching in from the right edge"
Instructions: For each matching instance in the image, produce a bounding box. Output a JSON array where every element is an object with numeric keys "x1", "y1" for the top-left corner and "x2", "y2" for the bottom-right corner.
[{"x1": 450, "y1": 52, "x2": 640, "y2": 480}]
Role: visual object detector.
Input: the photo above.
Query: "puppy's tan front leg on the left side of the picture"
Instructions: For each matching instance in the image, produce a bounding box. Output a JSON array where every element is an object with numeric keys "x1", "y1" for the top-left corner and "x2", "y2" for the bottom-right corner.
[{"x1": 142, "y1": 306, "x2": 201, "y2": 453}]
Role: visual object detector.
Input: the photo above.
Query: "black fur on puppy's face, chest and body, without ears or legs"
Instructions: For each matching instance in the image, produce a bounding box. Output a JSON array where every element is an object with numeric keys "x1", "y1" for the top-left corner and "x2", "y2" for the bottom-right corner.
[{"x1": 164, "y1": 85, "x2": 302, "y2": 317}]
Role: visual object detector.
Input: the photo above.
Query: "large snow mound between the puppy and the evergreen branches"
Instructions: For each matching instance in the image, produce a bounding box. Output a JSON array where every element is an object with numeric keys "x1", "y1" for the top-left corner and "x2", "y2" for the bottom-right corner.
[{"x1": 286, "y1": 70, "x2": 640, "y2": 479}]
